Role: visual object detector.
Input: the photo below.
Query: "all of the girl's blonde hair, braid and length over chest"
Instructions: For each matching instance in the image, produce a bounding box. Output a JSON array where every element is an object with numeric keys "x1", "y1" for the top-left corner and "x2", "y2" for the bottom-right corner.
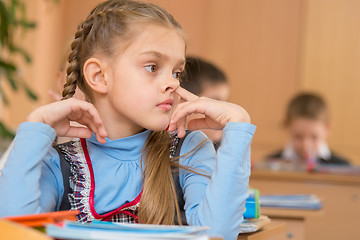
[{"x1": 62, "y1": 0, "x2": 203, "y2": 224}]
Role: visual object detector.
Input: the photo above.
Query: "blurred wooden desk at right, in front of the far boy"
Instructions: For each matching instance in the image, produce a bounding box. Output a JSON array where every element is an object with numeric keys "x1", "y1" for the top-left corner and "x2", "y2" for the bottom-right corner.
[{"x1": 250, "y1": 169, "x2": 360, "y2": 240}]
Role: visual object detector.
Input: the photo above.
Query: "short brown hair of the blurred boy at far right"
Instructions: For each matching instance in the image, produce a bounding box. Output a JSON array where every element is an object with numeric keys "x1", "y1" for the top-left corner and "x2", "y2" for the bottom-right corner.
[{"x1": 284, "y1": 93, "x2": 329, "y2": 126}]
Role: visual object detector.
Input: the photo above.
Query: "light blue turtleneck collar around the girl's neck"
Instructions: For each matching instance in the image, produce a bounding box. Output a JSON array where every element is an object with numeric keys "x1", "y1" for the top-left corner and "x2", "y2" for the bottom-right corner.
[{"x1": 87, "y1": 130, "x2": 151, "y2": 161}]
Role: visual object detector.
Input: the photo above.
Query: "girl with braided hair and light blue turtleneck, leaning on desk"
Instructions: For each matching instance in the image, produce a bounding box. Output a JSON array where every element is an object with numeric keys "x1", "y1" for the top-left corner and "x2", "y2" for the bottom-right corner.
[{"x1": 0, "y1": 0, "x2": 255, "y2": 239}]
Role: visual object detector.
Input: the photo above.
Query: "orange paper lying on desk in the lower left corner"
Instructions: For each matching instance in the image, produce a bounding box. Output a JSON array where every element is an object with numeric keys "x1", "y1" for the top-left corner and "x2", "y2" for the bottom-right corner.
[{"x1": 6, "y1": 211, "x2": 79, "y2": 227}]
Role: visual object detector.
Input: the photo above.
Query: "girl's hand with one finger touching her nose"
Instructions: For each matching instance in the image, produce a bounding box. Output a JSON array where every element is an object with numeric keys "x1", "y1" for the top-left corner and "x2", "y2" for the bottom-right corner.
[{"x1": 169, "y1": 87, "x2": 250, "y2": 138}]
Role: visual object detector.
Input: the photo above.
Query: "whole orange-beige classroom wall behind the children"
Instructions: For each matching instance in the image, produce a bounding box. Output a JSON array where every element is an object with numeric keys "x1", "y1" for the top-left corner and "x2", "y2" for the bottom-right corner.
[{"x1": 1, "y1": 0, "x2": 360, "y2": 164}]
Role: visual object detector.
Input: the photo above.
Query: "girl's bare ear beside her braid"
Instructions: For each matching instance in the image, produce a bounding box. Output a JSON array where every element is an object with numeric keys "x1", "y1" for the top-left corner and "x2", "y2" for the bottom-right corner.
[{"x1": 83, "y1": 58, "x2": 109, "y2": 94}]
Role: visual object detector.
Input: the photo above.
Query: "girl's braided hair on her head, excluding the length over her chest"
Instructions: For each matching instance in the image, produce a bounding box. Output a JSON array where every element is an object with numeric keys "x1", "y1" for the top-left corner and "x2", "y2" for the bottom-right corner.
[{"x1": 62, "y1": 0, "x2": 184, "y2": 99}]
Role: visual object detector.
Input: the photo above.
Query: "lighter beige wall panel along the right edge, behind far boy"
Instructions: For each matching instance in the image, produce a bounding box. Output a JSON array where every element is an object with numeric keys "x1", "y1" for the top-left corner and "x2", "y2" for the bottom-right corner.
[{"x1": 301, "y1": 0, "x2": 360, "y2": 164}]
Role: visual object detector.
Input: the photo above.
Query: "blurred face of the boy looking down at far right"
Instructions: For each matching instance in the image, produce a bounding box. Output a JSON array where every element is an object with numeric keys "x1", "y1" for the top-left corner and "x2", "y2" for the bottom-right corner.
[{"x1": 287, "y1": 118, "x2": 329, "y2": 159}]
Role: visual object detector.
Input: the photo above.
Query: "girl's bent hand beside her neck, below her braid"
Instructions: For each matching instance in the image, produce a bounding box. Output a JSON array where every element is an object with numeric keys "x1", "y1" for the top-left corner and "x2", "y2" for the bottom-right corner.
[{"x1": 27, "y1": 98, "x2": 107, "y2": 143}]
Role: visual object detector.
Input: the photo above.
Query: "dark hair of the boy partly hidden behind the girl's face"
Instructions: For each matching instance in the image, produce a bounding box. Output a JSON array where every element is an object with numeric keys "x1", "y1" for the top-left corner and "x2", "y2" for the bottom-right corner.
[{"x1": 181, "y1": 56, "x2": 227, "y2": 95}]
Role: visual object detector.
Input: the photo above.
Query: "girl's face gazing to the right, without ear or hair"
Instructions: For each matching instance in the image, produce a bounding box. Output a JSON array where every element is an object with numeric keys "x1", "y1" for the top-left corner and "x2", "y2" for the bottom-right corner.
[{"x1": 100, "y1": 24, "x2": 185, "y2": 137}]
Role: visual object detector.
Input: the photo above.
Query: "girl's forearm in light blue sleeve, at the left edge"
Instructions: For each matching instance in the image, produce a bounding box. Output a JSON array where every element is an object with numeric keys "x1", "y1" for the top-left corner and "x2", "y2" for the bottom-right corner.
[{"x1": 0, "y1": 123, "x2": 55, "y2": 217}]
